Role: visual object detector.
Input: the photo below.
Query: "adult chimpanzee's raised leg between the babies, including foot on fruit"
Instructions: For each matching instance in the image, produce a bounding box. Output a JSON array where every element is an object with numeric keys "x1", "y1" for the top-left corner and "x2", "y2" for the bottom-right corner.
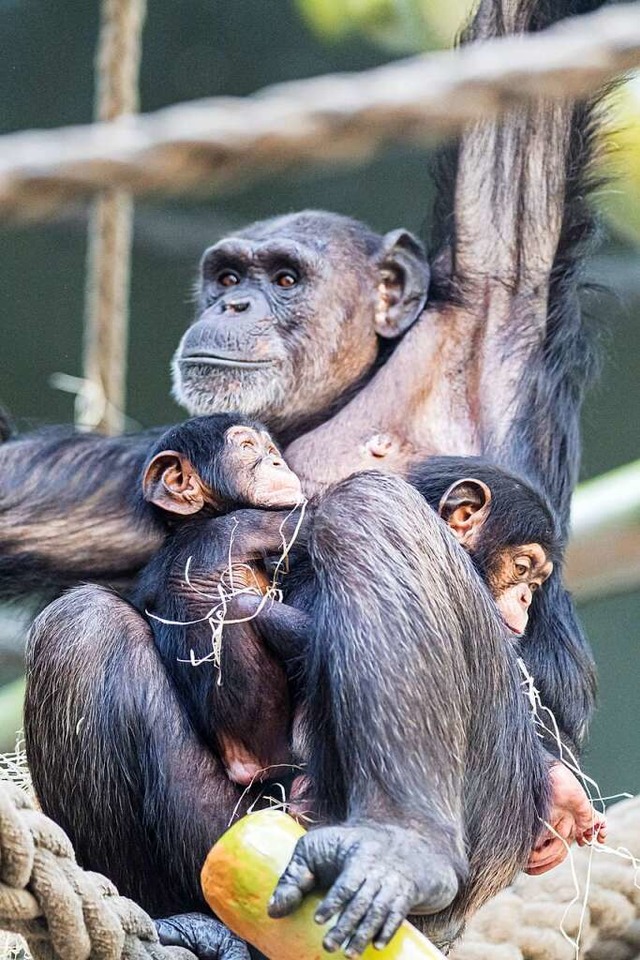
[{"x1": 271, "y1": 473, "x2": 546, "y2": 953}]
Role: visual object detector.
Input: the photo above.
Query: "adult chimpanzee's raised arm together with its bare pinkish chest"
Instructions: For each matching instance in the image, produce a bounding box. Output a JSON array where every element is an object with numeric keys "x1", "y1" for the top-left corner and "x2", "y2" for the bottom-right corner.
[{"x1": 286, "y1": 0, "x2": 601, "y2": 764}]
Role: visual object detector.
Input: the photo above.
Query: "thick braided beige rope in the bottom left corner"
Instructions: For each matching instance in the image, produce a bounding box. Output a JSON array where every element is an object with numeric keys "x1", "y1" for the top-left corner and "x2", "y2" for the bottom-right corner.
[{"x1": 0, "y1": 781, "x2": 193, "y2": 960}]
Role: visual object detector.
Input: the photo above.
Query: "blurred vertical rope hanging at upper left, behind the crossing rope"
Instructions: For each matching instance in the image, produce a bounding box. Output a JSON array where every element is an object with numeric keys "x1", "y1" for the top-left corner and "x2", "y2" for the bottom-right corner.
[{"x1": 76, "y1": 0, "x2": 146, "y2": 434}]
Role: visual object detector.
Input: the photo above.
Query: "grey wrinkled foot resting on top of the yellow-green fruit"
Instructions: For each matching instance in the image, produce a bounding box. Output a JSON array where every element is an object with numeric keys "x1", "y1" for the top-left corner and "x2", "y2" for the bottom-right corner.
[{"x1": 269, "y1": 824, "x2": 458, "y2": 957}]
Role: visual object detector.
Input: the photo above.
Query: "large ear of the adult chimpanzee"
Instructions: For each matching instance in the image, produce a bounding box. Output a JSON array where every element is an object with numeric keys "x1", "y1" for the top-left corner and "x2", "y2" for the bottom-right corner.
[{"x1": 375, "y1": 230, "x2": 431, "y2": 339}]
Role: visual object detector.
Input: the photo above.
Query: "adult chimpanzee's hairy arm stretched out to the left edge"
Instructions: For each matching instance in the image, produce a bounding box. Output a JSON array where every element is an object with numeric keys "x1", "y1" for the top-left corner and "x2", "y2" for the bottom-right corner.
[{"x1": 0, "y1": 429, "x2": 162, "y2": 598}]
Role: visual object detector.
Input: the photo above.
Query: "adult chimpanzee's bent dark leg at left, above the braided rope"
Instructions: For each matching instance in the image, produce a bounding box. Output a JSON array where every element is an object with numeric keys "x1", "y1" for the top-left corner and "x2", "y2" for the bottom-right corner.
[{"x1": 25, "y1": 586, "x2": 252, "y2": 924}]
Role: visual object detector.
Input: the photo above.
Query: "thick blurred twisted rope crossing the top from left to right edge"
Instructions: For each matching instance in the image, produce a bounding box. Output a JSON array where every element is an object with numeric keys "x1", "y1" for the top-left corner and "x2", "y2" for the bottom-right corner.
[{"x1": 0, "y1": 3, "x2": 640, "y2": 220}]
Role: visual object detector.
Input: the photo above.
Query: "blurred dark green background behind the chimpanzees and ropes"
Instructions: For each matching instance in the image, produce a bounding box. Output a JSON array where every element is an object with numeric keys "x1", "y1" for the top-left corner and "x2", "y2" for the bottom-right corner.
[{"x1": 0, "y1": 0, "x2": 640, "y2": 795}]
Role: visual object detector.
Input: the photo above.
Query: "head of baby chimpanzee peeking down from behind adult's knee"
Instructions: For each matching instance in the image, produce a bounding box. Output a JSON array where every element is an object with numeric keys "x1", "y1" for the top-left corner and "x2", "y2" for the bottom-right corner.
[{"x1": 412, "y1": 457, "x2": 561, "y2": 634}]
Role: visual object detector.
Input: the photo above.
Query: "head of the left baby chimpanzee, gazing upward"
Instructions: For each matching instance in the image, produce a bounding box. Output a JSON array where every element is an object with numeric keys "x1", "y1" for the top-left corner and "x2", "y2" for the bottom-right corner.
[{"x1": 142, "y1": 414, "x2": 302, "y2": 518}]
